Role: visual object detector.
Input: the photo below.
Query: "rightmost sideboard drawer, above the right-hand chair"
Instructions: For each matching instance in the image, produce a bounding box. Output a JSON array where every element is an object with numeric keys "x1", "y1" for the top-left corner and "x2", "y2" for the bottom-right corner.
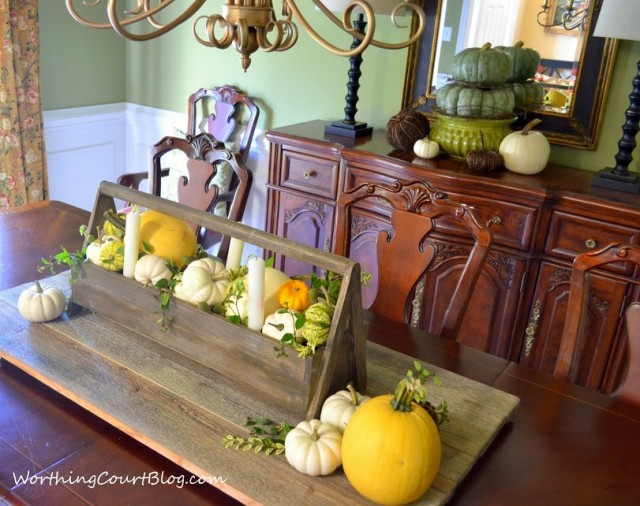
[{"x1": 545, "y1": 211, "x2": 640, "y2": 276}]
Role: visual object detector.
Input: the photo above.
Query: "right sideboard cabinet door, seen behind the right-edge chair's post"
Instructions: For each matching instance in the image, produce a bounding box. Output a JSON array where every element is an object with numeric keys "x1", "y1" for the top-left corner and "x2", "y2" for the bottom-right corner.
[{"x1": 520, "y1": 262, "x2": 628, "y2": 389}]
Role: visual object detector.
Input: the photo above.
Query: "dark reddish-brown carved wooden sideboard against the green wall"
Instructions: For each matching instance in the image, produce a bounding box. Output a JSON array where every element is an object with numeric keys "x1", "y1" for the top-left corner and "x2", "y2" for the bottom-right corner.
[{"x1": 266, "y1": 121, "x2": 640, "y2": 393}]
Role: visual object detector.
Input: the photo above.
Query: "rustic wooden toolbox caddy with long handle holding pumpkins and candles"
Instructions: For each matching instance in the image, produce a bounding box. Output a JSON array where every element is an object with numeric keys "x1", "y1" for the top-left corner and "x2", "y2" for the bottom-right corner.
[{"x1": 72, "y1": 182, "x2": 366, "y2": 419}]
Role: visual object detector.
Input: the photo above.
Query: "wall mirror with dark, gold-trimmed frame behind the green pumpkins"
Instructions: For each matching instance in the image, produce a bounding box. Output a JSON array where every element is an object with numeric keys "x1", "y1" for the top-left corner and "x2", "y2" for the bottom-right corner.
[{"x1": 403, "y1": 0, "x2": 617, "y2": 149}]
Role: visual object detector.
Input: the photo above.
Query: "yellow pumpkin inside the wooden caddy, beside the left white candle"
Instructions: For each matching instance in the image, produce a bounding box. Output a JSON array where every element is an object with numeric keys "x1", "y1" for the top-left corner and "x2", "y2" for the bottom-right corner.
[{"x1": 140, "y1": 209, "x2": 197, "y2": 268}]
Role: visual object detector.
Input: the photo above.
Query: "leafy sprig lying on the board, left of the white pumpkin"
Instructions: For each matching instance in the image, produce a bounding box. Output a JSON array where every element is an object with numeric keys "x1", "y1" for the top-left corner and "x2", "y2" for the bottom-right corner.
[{"x1": 222, "y1": 417, "x2": 293, "y2": 455}]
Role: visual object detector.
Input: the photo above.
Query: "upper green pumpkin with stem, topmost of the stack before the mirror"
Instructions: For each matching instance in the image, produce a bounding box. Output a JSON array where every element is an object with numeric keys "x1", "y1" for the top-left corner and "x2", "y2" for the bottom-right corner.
[{"x1": 452, "y1": 42, "x2": 511, "y2": 86}]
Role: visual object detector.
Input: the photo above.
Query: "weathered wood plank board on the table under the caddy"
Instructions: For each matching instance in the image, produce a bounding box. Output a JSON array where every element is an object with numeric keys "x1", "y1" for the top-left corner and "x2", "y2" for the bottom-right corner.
[{"x1": 0, "y1": 273, "x2": 526, "y2": 506}]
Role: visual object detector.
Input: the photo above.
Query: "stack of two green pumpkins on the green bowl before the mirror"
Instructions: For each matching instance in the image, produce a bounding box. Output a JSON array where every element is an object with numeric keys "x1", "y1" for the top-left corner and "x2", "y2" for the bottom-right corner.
[{"x1": 436, "y1": 42, "x2": 515, "y2": 118}]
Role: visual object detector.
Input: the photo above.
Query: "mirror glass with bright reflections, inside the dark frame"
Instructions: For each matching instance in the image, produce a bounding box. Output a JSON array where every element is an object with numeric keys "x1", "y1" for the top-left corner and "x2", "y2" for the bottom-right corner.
[{"x1": 430, "y1": 0, "x2": 585, "y2": 114}]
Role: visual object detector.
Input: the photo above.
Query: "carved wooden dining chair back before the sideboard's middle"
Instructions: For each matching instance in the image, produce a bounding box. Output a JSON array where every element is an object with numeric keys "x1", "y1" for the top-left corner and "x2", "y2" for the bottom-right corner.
[{"x1": 335, "y1": 181, "x2": 492, "y2": 339}]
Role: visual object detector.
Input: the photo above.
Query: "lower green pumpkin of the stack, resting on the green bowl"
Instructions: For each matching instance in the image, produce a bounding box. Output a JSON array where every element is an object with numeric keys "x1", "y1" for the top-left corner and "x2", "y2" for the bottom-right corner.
[{"x1": 436, "y1": 82, "x2": 515, "y2": 118}]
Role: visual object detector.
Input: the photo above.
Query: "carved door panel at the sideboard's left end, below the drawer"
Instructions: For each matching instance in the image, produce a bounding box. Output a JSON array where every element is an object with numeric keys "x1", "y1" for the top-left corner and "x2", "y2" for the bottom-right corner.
[{"x1": 275, "y1": 192, "x2": 334, "y2": 276}]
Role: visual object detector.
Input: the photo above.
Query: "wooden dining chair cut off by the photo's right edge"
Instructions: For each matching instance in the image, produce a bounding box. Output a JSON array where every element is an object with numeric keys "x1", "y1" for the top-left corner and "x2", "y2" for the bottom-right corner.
[{"x1": 553, "y1": 243, "x2": 640, "y2": 405}]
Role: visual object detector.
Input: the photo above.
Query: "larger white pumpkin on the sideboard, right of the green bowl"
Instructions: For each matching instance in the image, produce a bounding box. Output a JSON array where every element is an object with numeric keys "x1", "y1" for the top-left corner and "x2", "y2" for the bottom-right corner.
[{"x1": 498, "y1": 118, "x2": 551, "y2": 175}]
